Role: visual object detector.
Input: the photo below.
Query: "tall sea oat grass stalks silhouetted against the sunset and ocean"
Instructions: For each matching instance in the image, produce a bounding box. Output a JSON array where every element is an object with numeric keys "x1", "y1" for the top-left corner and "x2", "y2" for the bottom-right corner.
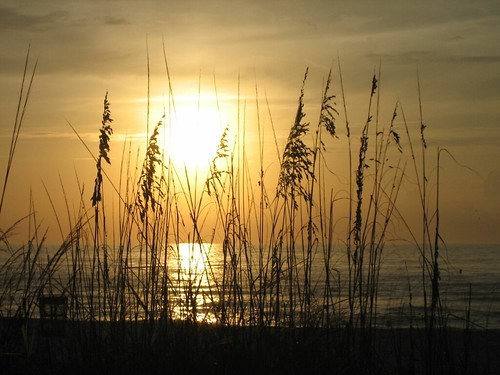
[{"x1": 0, "y1": 54, "x2": 480, "y2": 373}]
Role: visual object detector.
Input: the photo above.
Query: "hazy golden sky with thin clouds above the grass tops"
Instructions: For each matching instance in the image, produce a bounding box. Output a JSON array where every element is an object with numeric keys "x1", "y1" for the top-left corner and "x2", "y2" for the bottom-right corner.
[{"x1": 0, "y1": 0, "x2": 500, "y2": 243}]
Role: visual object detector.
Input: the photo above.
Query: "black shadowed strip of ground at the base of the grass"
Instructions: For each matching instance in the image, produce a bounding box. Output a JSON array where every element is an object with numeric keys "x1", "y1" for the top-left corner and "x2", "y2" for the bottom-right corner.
[{"x1": 0, "y1": 318, "x2": 500, "y2": 375}]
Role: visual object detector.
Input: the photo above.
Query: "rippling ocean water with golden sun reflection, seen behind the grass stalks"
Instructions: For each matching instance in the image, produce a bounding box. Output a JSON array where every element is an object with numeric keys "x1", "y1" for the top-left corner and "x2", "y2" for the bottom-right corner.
[{"x1": 0, "y1": 243, "x2": 500, "y2": 328}]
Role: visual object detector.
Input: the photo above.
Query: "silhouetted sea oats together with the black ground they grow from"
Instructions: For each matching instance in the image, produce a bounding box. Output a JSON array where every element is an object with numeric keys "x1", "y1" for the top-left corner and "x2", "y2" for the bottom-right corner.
[{"x1": 0, "y1": 52, "x2": 499, "y2": 374}]
